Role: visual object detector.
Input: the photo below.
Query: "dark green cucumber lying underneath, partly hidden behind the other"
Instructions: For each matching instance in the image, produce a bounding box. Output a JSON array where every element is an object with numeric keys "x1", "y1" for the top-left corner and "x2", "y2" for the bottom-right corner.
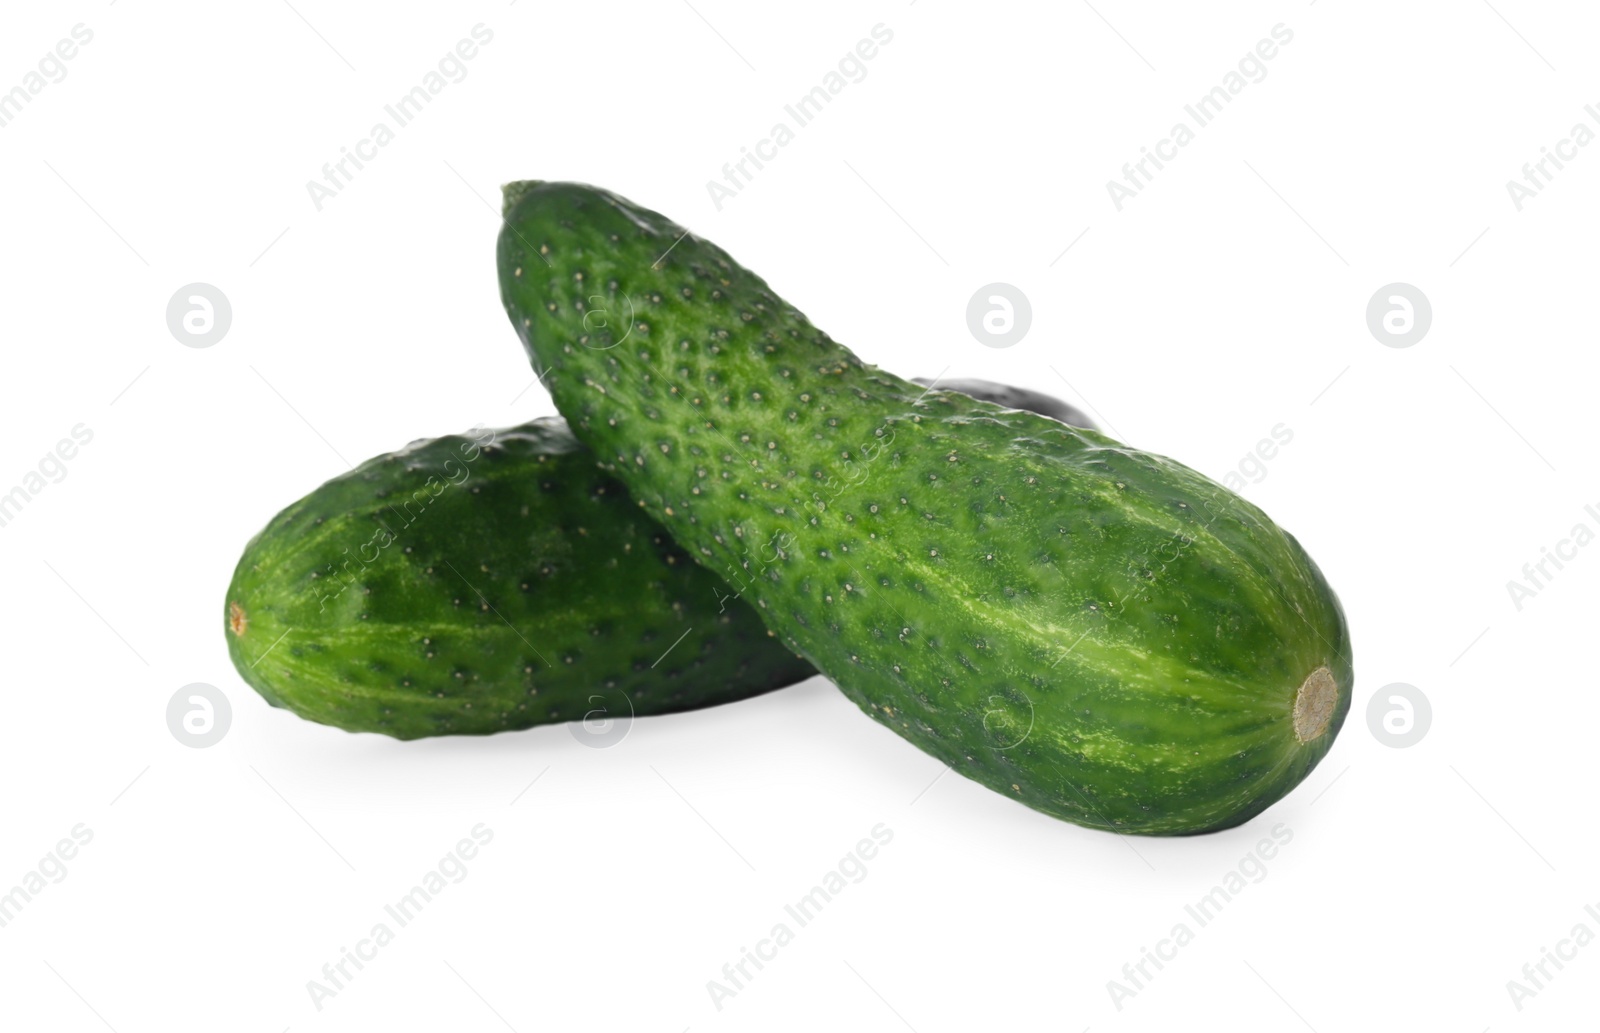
[{"x1": 224, "y1": 381, "x2": 1088, "y2": 744}]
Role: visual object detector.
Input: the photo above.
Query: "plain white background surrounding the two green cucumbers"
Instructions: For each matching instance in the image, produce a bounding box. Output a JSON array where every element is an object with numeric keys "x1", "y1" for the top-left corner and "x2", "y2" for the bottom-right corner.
[{"x1": 0, "y1": 0, "x2": 1600, "y2": 1033}]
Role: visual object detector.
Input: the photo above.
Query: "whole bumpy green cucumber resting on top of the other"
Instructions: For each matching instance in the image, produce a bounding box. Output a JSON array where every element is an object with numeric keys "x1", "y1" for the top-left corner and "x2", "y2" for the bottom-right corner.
[{"x1": 498, "y1": 182, "x2": 1352, "y2": 835}]
